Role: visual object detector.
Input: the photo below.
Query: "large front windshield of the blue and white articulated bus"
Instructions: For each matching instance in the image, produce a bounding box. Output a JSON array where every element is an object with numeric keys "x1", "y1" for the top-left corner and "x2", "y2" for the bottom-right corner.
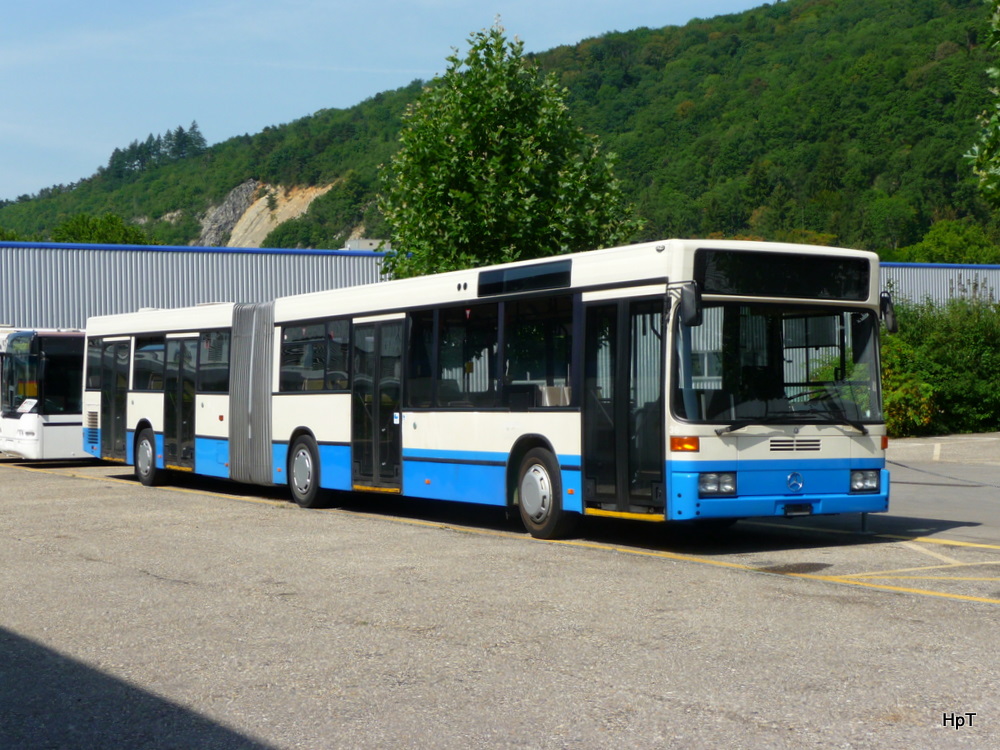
[{"x1": 672, "y1": 302, "x2": 882, "y2": 434}]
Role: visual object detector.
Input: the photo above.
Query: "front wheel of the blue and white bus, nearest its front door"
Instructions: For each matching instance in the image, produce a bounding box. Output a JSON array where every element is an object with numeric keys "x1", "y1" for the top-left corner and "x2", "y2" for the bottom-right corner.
[{"x1": 517, "y1": 448, "x2": 579, "y2": 539}]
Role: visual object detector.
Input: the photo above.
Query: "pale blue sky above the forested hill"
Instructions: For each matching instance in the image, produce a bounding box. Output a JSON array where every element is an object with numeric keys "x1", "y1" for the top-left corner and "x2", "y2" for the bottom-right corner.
[{"x1": 0, "y1": 0, "x2": 766, "y2": 199}]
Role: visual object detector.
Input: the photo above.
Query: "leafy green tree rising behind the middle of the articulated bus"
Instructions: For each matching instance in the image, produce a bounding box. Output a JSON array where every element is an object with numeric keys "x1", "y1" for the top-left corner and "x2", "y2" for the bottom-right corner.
[{"x1": 379, "y1": 23, "x2": 640, "y2": 277}]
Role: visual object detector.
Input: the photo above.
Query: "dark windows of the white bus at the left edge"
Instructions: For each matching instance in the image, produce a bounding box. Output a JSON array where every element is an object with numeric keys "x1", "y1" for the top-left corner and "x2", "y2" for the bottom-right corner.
[{"x1": 0, "y1": 333, "x2": 83, "y2": 416}]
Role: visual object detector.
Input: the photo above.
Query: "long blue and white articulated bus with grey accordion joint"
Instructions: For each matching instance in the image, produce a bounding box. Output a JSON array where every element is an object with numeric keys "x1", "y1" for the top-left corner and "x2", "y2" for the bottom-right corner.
[{"x1": 84, "y1": 240, "x2": 894, "y2": 538}]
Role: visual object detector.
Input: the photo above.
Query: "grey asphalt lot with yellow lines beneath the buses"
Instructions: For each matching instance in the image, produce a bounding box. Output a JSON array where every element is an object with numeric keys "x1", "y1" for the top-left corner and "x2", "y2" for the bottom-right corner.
[{"x1": 0, "y1": 434, "x2": 1000, "y2": 750}]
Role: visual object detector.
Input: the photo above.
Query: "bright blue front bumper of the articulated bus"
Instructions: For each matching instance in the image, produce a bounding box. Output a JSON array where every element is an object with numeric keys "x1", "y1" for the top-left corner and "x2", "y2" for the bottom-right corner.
[{"x1": 667, "y1": 470, "x2": 889, "y2": 521}]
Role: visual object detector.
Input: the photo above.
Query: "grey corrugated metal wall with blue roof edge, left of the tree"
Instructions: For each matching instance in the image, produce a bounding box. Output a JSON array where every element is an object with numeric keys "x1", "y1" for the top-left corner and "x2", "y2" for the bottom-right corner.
[{"x1": 0, "y1": 242, "x2": 383, "y2": 328}]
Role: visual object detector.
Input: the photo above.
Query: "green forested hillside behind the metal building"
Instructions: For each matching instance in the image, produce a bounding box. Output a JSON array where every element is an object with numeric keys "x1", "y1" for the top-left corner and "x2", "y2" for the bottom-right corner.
[{"x1": 0, "y1": 0, "x2": 996, "y2": 256}]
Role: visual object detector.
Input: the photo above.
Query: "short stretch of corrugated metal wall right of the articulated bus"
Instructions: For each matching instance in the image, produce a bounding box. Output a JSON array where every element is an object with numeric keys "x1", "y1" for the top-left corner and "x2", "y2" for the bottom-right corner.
[{"x1": 882, "y1": 263, "x2": 1000, "y2": 304}]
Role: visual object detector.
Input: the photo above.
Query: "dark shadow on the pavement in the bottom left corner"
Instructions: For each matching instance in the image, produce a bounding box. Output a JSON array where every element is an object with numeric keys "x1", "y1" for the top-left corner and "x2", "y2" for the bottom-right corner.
[{"x1": 0, "y1": 628, "x2": 271, "y2": 750}]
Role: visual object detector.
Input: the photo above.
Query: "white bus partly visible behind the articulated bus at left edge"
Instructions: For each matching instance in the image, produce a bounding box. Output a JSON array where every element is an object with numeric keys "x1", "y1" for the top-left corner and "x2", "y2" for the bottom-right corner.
[{"x1": 0, "y1": 327, "x2": 87, "y2": 459}]
